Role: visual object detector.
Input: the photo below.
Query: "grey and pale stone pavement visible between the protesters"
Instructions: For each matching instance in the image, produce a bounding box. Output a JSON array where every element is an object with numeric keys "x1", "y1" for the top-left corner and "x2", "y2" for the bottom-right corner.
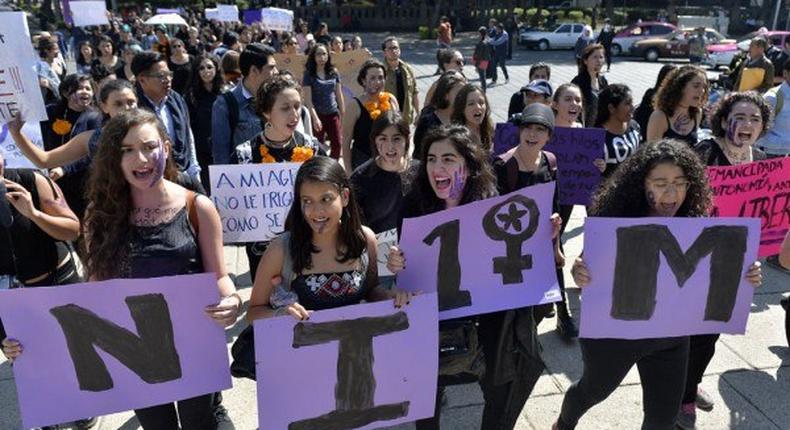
[{"x1": 0, "y1": 33, "x2": 790, "y2": 430}]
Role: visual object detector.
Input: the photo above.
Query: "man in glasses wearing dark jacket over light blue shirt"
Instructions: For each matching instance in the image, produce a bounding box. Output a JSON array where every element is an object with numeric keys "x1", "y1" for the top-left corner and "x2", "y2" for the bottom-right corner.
[{"x1": 132, "y1": 51, "x2": 200, "y2": 178}]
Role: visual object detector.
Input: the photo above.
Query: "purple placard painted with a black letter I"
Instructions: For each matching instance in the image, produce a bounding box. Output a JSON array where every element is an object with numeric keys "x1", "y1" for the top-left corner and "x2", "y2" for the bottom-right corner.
[{"x1": 255, "y1": 294, "x2": 439, "y2": 430}]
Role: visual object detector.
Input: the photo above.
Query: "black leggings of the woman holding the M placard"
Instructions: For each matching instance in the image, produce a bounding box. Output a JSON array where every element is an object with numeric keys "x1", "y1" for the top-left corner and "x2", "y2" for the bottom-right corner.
[{"x1": 557, "y1": 337, "x2": 689, "y2": 430}]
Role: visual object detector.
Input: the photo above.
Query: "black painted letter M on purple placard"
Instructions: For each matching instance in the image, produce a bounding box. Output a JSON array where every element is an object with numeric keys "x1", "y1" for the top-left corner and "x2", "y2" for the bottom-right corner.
[{"x1": 611, "y1": 224, "x2": 748, "y2": 322}]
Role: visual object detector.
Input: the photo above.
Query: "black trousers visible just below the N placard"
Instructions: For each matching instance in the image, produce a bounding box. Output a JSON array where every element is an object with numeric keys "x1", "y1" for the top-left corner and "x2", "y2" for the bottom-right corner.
[{"x1": 134, "y1": 394, "x2": 217, "y2": 430}]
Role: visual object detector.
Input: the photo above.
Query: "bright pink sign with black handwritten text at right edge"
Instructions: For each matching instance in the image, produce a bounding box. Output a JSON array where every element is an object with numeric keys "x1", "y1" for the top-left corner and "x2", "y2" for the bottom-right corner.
[{"x1": 708, "y1": 158, "x2": 790, "y2": 257}]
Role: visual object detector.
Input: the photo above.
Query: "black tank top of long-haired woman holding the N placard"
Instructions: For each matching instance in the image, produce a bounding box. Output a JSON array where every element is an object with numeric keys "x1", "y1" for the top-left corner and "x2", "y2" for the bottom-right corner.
[{"x1": 126, "y1": 206, "x2": 203, "y2": 278}]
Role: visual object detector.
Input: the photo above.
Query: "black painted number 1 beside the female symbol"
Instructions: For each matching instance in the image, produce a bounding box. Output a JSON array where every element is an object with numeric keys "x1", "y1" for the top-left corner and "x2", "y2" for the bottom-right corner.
[{"x1": 422, "y1": 219, "x2": 472, "y2": 311}]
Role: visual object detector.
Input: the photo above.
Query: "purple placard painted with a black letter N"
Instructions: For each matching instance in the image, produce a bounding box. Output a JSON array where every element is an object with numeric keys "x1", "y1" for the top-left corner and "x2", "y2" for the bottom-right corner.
[{"x1": 0, "y1": 273, "x2": 231, "y2": 428}]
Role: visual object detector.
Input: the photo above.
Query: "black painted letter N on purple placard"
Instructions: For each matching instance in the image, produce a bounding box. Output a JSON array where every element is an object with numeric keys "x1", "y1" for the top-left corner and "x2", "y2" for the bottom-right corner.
[{"x1": 49, "y1": 294, "x2": 181, "y2": 391}]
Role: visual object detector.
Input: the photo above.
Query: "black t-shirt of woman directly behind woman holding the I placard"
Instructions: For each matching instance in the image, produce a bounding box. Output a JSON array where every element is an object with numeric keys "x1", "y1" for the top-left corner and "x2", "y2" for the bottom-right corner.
[{"x1": 351, "y1": 159, "x2": 419, "y2": 233}]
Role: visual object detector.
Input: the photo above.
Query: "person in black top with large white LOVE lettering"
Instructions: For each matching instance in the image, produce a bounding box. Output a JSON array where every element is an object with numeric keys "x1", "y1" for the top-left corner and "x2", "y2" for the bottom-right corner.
[{"x1": 595, "y1": 84, "x2": 642, "y2": 178}]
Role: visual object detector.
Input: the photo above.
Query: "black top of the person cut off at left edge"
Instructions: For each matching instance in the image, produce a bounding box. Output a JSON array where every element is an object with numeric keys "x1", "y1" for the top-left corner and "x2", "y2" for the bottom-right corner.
[{"x1": 0, "y1": 169, "x2": 69, "y2": 280}]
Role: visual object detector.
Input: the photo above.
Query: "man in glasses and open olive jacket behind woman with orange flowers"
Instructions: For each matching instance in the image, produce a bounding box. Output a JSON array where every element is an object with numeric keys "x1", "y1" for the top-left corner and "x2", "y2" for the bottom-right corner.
[{"x1": 381, "y1": 36, "x2": 420, "y2": 124}]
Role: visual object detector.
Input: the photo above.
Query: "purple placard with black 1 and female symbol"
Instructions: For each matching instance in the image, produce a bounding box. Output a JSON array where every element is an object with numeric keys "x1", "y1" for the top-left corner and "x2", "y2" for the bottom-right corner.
[{"x1": 398, "y1": 182, "x2": 560, "y2": 320}]
